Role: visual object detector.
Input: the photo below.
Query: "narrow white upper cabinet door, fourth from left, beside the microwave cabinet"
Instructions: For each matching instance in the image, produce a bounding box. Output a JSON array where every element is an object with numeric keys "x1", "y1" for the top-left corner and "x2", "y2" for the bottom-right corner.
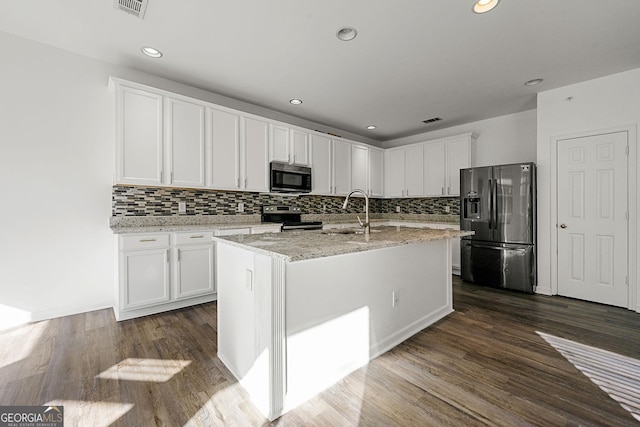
[{"x1": 240, "y1": 117, "x2": 269, "y2": 191}]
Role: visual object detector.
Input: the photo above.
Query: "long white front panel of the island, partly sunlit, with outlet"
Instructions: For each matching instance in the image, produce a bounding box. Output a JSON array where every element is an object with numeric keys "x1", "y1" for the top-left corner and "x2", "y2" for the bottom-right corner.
[{"x1": 285, "y1": 240, "x2": 453, "y2": 409}]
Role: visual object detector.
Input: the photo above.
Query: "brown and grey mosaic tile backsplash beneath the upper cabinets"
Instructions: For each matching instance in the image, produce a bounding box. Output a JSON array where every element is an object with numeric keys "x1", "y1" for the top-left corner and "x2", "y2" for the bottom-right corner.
[{"x1": 111, "y1": 185, "x2": 460, "y2": 217}]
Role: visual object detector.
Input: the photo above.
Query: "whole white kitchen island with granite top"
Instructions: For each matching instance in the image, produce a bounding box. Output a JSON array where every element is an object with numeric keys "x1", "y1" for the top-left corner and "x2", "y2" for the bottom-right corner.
[{"x1": 214, "y1": 226, "x2": 469, "y2": 420}]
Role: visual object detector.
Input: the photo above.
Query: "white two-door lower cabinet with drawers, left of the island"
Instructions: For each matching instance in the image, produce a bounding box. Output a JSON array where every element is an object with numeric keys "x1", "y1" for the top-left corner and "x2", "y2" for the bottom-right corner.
[{"x1": 119, "y1": 231, "x2": 216, "y2": 320}]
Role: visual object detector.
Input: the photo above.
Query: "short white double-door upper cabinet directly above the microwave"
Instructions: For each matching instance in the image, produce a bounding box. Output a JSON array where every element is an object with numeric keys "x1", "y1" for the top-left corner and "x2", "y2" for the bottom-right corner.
[{"x1": 269, "y1": 123, "x2": 310, "y2": 166}]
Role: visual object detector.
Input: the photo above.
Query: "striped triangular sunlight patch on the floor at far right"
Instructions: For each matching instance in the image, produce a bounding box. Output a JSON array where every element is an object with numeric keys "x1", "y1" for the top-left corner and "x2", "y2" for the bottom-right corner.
[{"x1": 537, "y1": 332, "x2": 640, "y2": 420}]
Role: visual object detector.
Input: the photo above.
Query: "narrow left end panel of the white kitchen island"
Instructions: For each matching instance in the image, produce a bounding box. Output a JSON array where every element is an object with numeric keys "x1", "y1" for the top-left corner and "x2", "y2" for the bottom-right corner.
[{"x1": 216, "y1": 242, "x2": 285, "y2": 420}]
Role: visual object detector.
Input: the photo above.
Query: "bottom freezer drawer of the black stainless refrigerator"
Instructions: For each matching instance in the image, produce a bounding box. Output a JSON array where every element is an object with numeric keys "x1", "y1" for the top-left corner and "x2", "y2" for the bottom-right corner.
[{"x1": 460, "y1": 240, "x2": 536, "y2": 293}]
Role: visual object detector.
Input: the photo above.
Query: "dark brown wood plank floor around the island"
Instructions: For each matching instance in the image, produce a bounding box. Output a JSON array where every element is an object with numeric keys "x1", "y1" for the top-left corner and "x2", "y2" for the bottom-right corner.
[{"x1": 0, "y1": 276, "x2": 640, "y2": 426}]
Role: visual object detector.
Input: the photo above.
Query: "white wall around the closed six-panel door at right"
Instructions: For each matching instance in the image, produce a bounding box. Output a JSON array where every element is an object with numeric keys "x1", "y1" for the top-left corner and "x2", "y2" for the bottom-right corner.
[{"x1": 537, "y1": 69, "x2": 640, "y2": 307}]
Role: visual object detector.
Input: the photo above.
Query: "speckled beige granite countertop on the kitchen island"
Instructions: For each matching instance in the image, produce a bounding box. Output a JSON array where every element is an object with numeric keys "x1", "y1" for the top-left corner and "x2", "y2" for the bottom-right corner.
[{"x1": 214, "y1": 226, "x2": 473, "y2": 262}]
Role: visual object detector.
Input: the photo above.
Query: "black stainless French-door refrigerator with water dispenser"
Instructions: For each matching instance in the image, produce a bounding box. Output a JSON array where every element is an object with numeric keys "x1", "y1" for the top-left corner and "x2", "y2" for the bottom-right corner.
[{"x1": 460, "y1": 163, "x2": 537, "y2": 293}]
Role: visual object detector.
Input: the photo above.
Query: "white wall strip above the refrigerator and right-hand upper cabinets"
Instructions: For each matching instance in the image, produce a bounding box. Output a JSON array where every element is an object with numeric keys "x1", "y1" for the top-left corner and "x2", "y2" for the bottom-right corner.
[{"x1": 384, "y1": 110, "x2": 536, "y2": 166}]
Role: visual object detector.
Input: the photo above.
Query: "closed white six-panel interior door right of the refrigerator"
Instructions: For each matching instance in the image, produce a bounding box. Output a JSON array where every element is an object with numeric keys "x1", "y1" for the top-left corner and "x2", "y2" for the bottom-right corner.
[{"x1": 557, "y1": 132, "x2": 629, "y2": 307}]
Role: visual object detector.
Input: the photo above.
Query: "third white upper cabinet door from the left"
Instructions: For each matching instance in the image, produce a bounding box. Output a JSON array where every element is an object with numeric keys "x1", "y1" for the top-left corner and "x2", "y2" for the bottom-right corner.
[{"x1": 209, "y1": 109, "x2": 240, "y2": 190}]
